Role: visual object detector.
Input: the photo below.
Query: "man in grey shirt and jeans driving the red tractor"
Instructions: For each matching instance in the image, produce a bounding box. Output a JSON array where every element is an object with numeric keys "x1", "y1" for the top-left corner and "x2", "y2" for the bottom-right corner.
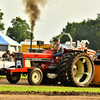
[{"x1": 52, "y1": 39, "x2": 64, "y2": 62}]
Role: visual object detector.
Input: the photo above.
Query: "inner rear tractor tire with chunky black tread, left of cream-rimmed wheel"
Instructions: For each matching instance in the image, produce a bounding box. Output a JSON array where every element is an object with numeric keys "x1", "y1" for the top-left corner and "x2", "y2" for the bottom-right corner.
[{"x1": 57, "y1": 52, "x2": 74, "y2": 86}]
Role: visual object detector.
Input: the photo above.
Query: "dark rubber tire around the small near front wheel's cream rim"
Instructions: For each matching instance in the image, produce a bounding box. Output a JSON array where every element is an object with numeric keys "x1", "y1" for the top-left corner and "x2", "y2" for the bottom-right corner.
[{"x1": 28, "y1": 68, "x2": 43, "y2": 85}]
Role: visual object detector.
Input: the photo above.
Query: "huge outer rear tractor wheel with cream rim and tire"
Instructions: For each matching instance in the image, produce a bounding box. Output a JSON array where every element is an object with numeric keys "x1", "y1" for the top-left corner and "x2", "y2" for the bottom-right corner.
[{"x1": 68, "y1": 53, "x2": 94, "y2": 86}]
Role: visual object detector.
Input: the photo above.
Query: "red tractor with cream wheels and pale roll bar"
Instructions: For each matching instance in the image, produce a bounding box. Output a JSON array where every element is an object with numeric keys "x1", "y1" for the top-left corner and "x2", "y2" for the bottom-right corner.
[{"x1": 6, "y1": 33, "x2": 95, "y2": 87}]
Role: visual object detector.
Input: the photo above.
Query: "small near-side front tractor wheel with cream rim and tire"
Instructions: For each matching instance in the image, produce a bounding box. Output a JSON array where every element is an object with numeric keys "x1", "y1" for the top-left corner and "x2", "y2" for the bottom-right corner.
[{"x1": 28, "y1": 68, "x2": 43, "y2": 85}]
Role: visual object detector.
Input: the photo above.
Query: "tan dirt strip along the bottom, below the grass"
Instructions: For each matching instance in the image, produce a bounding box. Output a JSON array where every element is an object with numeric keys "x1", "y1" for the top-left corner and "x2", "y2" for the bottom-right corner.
[{"x1": 0, "y1": 95, "x2": 100, "y2": 100}]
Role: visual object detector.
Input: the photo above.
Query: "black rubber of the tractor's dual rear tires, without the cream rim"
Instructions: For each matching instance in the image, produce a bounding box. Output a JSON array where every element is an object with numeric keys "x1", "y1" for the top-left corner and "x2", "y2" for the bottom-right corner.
[{"x1": 57, "y1": 52, "x2": 94, "y2": 87}]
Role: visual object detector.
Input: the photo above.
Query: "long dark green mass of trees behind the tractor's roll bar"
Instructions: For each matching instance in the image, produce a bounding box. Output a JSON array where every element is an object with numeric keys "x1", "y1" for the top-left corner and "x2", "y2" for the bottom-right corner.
[{"x1": 50, "y1": 14, "x2": 100, "y2": 51}]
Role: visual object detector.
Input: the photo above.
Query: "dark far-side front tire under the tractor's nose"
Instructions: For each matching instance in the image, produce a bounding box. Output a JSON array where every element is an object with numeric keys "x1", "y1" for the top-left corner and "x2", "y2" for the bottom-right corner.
[{"x1": 6, "y1": 73, "x2": 21, "y2": 84}]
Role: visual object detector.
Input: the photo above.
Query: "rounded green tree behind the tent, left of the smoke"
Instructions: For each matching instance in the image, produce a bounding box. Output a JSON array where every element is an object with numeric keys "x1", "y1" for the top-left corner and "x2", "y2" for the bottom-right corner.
[{"x1": 6, "y1": 17, "x2": 30, "y2": 43}]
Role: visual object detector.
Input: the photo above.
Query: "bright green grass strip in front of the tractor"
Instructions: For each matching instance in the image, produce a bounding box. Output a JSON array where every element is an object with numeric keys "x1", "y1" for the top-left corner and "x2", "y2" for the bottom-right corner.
[{"x1": 0, "y1": 85, "x2": 100, "y2": 92}]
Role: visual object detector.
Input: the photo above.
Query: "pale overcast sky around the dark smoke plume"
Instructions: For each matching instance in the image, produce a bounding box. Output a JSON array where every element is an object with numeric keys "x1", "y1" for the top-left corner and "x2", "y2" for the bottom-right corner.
[{"x1": 0, "y1": 0, "x2": 100, "y2": 44}]
